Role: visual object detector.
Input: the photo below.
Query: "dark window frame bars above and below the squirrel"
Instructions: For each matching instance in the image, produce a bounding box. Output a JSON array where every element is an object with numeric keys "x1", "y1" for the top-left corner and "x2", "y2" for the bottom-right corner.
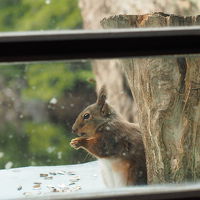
[{"x1": 0, "y1": 27, "x2": 200, "y2": 200}]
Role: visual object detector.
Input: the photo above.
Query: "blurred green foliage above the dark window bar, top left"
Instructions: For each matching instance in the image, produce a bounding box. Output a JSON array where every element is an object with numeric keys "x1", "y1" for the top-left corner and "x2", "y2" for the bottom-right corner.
[{"x1": 0, "y1": 0, "x2": 82, "y2": 31}]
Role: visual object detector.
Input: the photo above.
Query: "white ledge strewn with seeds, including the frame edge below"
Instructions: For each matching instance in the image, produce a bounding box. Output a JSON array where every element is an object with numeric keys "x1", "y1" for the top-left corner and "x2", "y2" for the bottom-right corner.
[{"x1": 0, "y1": 162, "x2": 200, "y2": 200}]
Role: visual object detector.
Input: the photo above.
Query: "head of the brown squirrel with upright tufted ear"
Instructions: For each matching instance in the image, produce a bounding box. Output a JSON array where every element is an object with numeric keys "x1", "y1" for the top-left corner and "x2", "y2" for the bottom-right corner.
[{"x1": 72, "y1": 86, "x2": 116, "y2": 137}]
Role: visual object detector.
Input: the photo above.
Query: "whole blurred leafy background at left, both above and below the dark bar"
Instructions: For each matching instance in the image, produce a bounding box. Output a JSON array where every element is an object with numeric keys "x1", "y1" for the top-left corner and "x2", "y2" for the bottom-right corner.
[{"x1": 0, "y1": 0, "x2": 95, "y2": 169}]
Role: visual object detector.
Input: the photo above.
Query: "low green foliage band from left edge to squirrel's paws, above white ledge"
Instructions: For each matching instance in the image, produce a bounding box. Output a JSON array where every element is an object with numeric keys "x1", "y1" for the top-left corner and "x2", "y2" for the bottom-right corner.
[{"x1": 0, "y1": 121, "x2": 82, "y2": 168}]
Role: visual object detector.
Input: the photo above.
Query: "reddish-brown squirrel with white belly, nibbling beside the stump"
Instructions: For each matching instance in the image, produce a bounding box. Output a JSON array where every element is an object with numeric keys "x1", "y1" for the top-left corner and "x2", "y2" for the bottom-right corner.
[{"x1": 70, "y1": 86, "x2": 147, "y2": 187}]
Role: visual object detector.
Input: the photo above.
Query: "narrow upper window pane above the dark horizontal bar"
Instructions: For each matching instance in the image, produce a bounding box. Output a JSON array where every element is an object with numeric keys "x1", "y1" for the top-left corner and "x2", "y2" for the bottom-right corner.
[{"x1": 0, "y1": 0, "x2": 200, "y2": 32}]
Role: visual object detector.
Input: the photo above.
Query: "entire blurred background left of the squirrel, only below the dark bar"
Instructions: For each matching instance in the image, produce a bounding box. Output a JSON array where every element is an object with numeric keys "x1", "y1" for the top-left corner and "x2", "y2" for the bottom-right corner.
[{"x1": 0, "y1": 61, "x2": 95, "y2": 169}]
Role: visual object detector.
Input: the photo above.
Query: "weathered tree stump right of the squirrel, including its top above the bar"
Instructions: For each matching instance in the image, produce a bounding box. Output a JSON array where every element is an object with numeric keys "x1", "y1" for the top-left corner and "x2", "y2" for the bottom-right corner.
[{"x1": 101, "y1": 13, "x2": 200, "y2": 183}]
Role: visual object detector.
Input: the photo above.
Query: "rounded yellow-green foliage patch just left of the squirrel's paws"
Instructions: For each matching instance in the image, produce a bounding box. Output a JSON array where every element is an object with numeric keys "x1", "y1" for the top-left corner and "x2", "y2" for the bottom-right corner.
[{"x1": 23, "y1": 121, "x2": 71, "y2": 165}]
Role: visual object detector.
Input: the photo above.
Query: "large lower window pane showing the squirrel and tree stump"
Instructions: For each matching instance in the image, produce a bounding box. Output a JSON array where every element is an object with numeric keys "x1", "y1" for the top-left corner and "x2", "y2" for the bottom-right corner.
[{"x1": 0, "y1": 55, "x2": 200, "y2": 199}]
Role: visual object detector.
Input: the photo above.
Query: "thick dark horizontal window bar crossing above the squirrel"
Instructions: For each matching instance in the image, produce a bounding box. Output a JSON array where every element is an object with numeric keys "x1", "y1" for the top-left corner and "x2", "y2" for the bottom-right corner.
[{"x1": 0, "y1": 26, "x2": 200, "y2": 62}]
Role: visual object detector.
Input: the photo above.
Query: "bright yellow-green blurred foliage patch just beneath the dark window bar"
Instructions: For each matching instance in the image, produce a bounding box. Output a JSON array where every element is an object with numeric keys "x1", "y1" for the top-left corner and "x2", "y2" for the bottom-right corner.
[{"x1": 23, "y1": 62, "x2": 93, "y2": 101}]
